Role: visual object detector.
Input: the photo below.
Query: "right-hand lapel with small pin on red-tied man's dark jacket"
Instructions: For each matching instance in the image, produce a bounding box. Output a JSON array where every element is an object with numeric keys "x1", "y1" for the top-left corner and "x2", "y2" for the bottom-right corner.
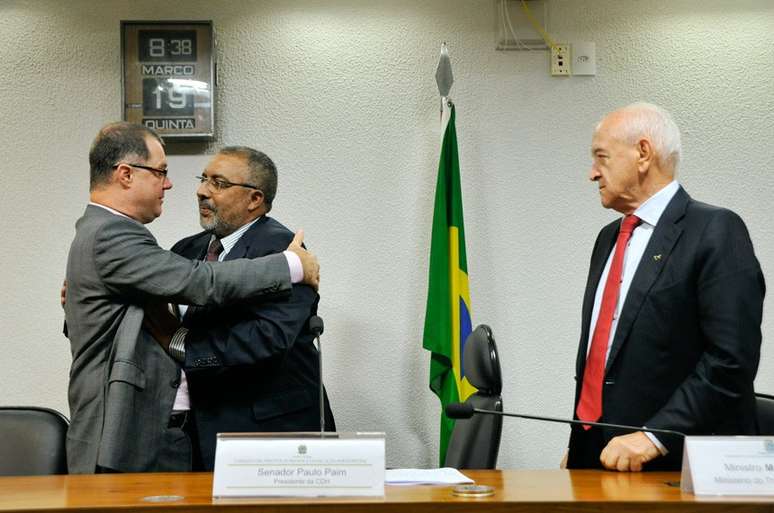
[{"x1": 605, "y1": 187, "x2": 691, "y2": 373}]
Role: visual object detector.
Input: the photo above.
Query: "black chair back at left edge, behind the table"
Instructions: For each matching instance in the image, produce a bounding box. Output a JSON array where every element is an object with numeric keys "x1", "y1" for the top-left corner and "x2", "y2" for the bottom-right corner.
[{"x1": 0, "y1": 406, "x2": 70, "y2": 476}]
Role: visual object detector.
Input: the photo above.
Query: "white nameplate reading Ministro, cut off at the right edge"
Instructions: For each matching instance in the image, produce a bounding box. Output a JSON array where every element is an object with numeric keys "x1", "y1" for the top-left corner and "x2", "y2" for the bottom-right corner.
[{"x1": 680, "y1": 436, "x2": 774, "y2": 495}]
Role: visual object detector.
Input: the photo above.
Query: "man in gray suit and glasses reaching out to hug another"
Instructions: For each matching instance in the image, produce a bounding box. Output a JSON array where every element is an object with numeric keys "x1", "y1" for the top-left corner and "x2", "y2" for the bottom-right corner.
[{"x1": 65, "y1": 123, "x2": 319, "y2": 473}]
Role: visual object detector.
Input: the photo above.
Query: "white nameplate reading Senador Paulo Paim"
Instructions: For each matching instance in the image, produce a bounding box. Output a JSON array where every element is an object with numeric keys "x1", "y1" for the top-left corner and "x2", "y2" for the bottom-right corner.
[{"x1": 212, "y1": 433, "x2": 385, "y2": 498}]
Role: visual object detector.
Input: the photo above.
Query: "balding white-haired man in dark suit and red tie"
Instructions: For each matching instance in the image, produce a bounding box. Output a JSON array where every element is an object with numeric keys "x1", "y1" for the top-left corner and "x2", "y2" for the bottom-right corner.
[{"x1": 567, "y1": 103, "x2": 765, "y2": 471}]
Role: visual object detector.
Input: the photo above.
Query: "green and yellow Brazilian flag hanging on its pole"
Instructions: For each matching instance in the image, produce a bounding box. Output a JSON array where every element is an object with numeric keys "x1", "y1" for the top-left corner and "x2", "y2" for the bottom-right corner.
[{"x1": 423, "y1": 101, "x2": 476, "y2": 466}]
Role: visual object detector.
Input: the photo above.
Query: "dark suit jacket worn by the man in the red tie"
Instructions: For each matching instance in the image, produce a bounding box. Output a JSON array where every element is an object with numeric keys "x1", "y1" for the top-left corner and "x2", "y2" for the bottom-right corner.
[{"x1": 568, "y1": 188, "x2": 766, "y2": 470}]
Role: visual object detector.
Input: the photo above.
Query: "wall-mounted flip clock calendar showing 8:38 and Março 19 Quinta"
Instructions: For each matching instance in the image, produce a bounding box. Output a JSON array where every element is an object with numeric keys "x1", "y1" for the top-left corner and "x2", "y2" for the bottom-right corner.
[{"x1": 121, "y1": 21, "x2": 215, "y2": 139}]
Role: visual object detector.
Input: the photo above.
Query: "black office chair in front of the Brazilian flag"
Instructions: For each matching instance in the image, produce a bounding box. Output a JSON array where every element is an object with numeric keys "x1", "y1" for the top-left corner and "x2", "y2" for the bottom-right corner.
[{"x1": 445, "y1": 324, "x2": 503, "y2": 469}]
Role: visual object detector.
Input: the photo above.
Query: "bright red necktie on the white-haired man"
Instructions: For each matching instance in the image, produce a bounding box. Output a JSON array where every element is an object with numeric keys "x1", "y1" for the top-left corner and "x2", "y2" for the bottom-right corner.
[{"x1": 575, "y1": 216, "x2": 640, "y2": 429}]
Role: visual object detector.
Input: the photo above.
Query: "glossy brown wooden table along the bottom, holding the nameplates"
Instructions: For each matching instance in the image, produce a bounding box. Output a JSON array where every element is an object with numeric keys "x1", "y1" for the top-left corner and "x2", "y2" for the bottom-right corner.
[{"x1": 0, "y1": 470, "x2": 774, "y2": 513}]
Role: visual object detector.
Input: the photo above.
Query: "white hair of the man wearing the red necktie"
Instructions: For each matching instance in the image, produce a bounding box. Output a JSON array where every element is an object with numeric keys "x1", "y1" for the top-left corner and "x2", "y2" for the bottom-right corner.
[{"x1": 597, "y1": 102, "x2": 682, "y2": 173}]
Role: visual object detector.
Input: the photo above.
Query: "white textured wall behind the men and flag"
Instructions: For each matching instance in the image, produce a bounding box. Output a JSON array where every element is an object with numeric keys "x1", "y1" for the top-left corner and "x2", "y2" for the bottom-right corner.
[{"x1": 0, "y1": 0, "x2": 774, "y2": 467}]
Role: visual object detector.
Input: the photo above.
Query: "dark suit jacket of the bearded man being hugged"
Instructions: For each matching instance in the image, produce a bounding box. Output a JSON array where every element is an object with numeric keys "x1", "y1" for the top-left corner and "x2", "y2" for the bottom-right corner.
[{"x1": 172, "y1": 216, "x2": 335, "y2": 470}]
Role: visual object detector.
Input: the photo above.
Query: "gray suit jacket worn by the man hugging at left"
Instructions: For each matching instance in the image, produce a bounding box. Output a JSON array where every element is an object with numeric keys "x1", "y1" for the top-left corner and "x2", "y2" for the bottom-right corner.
[{"x1": 65, "y1": 205, "x2": 291, "y2": 473}]
